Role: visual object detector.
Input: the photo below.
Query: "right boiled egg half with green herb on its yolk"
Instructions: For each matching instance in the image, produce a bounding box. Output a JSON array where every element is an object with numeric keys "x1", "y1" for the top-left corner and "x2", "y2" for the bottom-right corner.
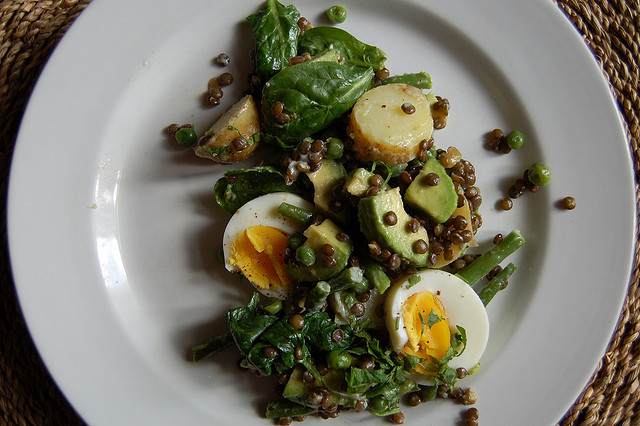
[{"x1": 385, "y1": 269, "x2": 489, "y2": 384}]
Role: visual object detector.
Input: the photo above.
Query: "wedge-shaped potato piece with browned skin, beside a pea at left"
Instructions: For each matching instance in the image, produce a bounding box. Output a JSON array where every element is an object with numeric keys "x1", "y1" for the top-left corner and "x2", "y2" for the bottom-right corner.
[{"x1": 194, "y1": 95, "x2": 260, "y2": 163}]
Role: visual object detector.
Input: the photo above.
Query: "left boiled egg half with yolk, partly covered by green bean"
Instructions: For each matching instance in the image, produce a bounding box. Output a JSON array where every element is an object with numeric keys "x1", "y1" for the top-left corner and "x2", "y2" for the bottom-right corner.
[{"x1": 222, "y1": 192, "x2": 313, "y2": 299}]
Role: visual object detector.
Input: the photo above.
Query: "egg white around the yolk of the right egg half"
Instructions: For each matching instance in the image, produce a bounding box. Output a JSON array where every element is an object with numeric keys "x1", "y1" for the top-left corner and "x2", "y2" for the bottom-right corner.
[{"x1": 385, "y1": 269, "x2": 489, "y2": 382}]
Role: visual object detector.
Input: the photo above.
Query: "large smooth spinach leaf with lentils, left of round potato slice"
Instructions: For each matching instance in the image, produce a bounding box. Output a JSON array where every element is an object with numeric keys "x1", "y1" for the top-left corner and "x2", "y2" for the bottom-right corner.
[{"x1": 262, "y1": 61, "x2": 373, "y2": 146}]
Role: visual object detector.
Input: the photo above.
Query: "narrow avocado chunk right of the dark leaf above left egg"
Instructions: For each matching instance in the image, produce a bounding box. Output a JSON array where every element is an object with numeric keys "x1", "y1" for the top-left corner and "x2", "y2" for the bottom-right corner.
[{"x1": 307, "y1": 159, "x2": 349, "y2": 223}]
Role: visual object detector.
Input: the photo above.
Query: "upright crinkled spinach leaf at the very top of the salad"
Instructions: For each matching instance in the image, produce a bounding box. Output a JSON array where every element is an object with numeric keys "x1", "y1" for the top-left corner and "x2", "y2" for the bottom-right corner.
[{"x1": 247, "y1": 0, "x2": 300, "y2": 77}]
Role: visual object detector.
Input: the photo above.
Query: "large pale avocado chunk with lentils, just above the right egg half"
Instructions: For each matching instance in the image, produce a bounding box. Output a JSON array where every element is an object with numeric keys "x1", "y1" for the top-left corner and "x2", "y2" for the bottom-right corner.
[{"x1": 358, "y1": 188, "x2": 429, "y2": 268}]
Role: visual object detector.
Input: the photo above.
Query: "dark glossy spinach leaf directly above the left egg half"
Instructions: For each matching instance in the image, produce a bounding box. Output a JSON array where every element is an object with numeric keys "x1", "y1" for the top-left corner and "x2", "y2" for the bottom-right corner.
[{"x1": 213, "y1": 166, "x2": 304, "y2": 213}]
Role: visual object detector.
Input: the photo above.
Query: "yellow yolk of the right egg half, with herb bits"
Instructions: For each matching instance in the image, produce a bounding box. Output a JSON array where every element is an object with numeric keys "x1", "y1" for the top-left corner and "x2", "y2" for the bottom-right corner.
[{"x1": 402, "y1": 291, "x2": 451, "y2": 374}]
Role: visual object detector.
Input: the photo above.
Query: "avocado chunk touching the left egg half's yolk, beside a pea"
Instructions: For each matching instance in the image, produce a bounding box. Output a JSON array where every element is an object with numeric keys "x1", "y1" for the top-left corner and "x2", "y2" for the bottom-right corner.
[{"x1": 286, "y1": 219, "x2": 353, "y2": 282}]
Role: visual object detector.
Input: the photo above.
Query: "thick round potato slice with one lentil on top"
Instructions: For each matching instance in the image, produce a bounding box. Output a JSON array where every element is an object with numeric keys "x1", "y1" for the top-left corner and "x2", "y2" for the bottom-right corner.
[{"x1": 347, "y1": 83, "x2": 433, "y2": 165}]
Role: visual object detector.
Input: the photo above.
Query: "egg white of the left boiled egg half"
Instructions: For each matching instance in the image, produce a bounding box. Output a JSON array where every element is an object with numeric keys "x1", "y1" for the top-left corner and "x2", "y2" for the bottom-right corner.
[{"x1": 222, "y1": 192, "x2": 313, "y2": 297}]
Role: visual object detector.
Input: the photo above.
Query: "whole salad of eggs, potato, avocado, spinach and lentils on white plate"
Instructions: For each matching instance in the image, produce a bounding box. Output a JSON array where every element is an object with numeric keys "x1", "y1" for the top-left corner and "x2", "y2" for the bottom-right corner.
[{"x1": 169, "y1": 0, "x2": 539, "y2": 424}]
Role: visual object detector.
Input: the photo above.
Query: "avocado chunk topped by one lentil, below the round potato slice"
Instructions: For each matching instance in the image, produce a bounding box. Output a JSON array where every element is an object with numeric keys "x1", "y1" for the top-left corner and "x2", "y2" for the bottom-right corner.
[{"x1": 404, "y1": 158, "x2": 458, "y2": 223}]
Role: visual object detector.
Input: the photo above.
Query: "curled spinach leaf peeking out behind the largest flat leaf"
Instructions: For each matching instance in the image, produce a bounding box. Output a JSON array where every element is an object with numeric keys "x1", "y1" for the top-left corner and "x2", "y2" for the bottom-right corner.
[{"x1": 298, "y1": 27, "x2": 387, "y2": 71}]
